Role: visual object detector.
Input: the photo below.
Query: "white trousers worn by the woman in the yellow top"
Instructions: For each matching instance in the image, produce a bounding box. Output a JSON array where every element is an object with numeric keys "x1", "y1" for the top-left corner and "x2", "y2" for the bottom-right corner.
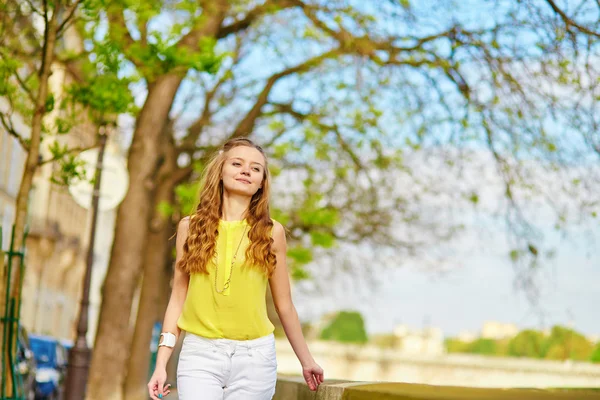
[{"x1": 177, "y1": 333, "x2": 277, "y2": 400}]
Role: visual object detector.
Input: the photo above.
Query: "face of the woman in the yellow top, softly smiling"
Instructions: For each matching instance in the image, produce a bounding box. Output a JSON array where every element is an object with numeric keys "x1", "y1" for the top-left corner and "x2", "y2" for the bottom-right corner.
[{"x1": 221, "y1": 146, "x2": 265, "y2": 196}]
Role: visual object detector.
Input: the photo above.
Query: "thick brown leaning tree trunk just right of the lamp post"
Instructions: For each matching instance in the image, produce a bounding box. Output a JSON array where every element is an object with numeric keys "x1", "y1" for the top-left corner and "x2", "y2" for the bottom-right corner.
[{"x1": 86, "y1": 75, "x2": 182, "y2": 400}]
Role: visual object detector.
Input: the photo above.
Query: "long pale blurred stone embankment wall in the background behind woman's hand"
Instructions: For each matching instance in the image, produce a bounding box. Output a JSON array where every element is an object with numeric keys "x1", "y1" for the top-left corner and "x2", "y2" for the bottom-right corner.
[{"x1": 276, "y1": 339, "x2": 600, "y2": 388}]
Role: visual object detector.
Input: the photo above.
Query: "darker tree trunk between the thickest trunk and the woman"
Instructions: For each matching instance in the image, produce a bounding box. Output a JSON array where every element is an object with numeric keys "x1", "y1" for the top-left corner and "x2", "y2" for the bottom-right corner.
[{"x1": 123, "y1": 130, "x2": 177, "y2": 400}]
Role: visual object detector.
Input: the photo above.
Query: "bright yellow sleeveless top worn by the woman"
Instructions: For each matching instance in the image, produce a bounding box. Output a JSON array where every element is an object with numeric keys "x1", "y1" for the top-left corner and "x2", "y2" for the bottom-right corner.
[{"x1": 177, "y1": 220, "x2": 275, "y2": 340}]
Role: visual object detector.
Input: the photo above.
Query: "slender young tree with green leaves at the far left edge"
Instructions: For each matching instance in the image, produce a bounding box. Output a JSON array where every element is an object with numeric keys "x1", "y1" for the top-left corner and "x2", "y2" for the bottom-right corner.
[{"x1": 0, "y1": 0, "x2": 86, "y2": 395}]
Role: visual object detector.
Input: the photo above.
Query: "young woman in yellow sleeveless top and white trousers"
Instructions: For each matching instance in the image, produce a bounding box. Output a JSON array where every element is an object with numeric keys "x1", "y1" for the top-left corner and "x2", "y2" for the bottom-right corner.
[{"x1": 148, "y1": 139, "x2": 323, "y2": 400}]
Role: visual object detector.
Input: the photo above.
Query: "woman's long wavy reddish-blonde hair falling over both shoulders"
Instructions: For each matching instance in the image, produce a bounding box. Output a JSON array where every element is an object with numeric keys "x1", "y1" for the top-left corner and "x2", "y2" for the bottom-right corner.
[{"x1": 177, "y1": 138, "x2": 276, "y2": 277}]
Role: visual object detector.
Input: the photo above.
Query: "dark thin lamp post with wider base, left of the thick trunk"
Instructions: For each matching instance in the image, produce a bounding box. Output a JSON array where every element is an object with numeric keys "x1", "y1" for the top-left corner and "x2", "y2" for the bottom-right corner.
[{"x1": 65, "y1": 125, "x2": 107, "y2": 400}]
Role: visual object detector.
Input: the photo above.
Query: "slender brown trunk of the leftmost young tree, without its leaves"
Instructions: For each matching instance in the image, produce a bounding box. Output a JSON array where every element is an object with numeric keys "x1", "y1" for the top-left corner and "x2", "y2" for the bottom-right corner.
[{"x1": 0, "y1": 10, "x2": 58, "y2": 396}]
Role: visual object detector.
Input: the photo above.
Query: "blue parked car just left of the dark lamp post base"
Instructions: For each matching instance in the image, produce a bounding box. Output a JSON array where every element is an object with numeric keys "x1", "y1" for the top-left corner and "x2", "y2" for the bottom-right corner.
[{"x1": 29, "y1": 335, "x2": 67, "y2": 400}]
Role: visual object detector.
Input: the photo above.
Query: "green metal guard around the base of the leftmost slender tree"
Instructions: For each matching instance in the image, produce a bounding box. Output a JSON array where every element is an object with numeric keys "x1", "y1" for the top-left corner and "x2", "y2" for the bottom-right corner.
[{"x1": 0, "y1": 227, "x2": 26, "y2": 400}]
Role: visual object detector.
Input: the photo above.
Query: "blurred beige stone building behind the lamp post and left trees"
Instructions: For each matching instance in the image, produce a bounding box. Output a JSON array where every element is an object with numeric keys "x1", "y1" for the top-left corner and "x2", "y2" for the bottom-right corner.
[{"x1": 0, "y1": 59, "x2": 115, "y2": 345}]
